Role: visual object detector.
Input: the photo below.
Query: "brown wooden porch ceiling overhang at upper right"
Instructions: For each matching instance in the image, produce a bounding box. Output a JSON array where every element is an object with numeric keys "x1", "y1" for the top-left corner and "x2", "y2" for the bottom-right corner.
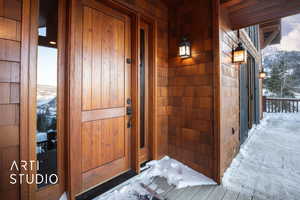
[{"x1": 221, "y1": 0, "x2": 300, "y2": 29}]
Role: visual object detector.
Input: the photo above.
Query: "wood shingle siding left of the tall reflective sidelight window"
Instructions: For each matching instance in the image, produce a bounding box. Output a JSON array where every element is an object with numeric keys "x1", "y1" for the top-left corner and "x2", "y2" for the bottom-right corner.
[{"x1": 0, "y1": 0, "x2": 21, "y2": 200}]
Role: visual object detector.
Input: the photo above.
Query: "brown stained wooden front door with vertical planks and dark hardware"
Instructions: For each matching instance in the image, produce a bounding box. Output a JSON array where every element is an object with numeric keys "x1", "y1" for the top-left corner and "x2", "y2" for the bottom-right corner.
[{"x1": 81, "y1": 3, "x2": 130, "y2": 190}]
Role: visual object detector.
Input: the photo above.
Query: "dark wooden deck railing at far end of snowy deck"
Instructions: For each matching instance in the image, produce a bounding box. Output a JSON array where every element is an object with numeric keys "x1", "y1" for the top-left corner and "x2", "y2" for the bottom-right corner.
[{"x1": 263, "y1": 97, "x2": 300, "y2": 113}]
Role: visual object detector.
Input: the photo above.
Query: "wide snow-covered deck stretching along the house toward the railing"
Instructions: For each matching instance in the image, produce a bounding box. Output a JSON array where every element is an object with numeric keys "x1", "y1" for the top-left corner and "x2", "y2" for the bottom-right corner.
[{"x1": 223, "y1": 113, "x2": 300, "y2": 200}]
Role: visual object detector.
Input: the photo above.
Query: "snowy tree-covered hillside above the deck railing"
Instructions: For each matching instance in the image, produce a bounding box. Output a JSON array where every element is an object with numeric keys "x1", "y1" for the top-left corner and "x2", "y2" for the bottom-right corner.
[{"x1": 263, "y1": 49, "x2": 300, "y2": 98}]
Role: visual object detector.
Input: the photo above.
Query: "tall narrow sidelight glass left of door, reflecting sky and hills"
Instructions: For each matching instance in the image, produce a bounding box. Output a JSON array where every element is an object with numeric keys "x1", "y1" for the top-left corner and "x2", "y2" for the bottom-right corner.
[{"x1": 36, "y1": 0, "x2": 58, "y2": 188}]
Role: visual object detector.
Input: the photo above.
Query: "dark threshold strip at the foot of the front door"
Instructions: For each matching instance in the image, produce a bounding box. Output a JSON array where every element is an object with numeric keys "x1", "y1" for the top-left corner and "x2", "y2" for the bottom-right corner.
[{"x1": 76, "y1": 170, "x2": 137, "y2": 200}]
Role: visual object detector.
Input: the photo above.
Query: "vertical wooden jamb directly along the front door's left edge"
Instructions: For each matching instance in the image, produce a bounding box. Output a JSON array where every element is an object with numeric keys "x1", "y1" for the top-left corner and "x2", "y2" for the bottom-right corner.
[{"x1": 67, "y1": 0, "x2": 83, "y2": 199}]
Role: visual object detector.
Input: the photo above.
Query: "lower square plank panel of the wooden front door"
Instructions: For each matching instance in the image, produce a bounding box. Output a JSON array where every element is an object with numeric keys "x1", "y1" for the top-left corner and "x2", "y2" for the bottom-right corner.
[{"x1": 82, "y1": 117, "x2": 125, "y2": 172}]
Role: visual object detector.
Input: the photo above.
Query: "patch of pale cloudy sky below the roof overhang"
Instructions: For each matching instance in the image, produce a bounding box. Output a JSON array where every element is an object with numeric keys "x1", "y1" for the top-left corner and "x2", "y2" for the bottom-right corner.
[{"x1": 267, "y1": 14, "x2": 300, "y2": 51}]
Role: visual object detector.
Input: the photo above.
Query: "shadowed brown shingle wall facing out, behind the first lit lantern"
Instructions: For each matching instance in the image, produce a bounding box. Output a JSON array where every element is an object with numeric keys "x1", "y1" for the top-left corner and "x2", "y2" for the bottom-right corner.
[{"x1": 169, "y1": 1, "x2": 215, "y2": 177}]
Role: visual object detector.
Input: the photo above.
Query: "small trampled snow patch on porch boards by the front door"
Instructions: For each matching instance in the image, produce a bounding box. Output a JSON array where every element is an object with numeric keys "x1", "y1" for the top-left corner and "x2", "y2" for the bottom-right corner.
[{"x1": 94, "y1": 156, "x2": 216, "y2": 200}]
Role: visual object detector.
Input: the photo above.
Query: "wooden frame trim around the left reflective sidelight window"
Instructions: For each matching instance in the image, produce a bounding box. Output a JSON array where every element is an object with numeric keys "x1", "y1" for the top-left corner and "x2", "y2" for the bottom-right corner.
[{"x1": 20, "y1": 0, "x2": 67, "y2": 200}]
